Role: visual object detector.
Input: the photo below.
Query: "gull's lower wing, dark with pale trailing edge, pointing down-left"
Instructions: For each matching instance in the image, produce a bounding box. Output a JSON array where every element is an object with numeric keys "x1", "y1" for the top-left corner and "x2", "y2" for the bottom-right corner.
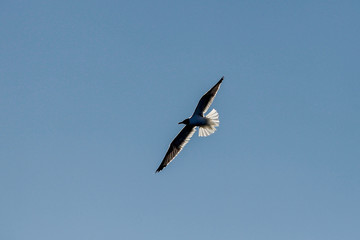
[{"x1": 156, "y1": 125, "x2": 196, "y2": 172}]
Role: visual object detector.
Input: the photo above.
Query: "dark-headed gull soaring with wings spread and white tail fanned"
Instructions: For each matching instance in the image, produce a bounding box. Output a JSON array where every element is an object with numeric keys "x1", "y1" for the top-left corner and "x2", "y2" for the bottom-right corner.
[{"x1": 156, "y1": 77, "x2": 224, "y2": 173}]
